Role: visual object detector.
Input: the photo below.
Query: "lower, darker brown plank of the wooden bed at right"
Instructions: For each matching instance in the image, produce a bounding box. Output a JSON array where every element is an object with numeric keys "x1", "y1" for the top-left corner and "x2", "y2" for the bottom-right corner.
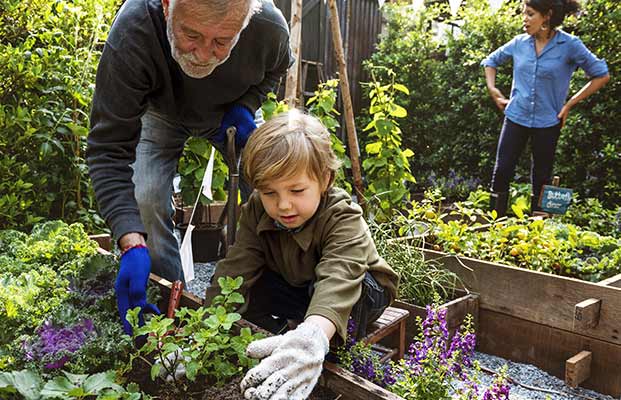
[{"x1": 477, "y1": 308, "x2": 621, "y2": 398}]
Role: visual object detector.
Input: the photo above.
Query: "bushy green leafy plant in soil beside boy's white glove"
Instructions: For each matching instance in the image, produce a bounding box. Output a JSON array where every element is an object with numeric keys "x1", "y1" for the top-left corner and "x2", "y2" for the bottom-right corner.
[{"x1": 127, "y1": 277, "x2": 262, "y2": 390}]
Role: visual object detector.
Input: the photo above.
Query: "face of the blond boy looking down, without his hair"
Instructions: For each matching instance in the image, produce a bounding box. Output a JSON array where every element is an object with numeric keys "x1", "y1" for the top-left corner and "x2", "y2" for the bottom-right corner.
[{"x1": 259, "y1": 172, "x2": 328, "y2": 228}]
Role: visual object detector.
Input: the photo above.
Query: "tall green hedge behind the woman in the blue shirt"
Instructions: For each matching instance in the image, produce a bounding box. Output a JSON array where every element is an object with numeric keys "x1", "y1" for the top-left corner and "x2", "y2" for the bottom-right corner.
[{"x1": 372, "y1": 0, "x2": 621, "y2": 204}]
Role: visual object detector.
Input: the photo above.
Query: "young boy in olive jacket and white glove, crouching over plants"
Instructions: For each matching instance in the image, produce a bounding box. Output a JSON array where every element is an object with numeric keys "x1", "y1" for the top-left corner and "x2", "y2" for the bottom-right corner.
[{"x1": 206, "y1": 110, "x2": 398, "y2": 399}]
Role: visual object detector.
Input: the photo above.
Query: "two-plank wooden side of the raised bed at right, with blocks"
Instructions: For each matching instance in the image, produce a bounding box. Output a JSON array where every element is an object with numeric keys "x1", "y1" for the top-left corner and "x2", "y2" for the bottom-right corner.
[{"x1": 421, "y1": 249, "x2": 621, "y2": 397}]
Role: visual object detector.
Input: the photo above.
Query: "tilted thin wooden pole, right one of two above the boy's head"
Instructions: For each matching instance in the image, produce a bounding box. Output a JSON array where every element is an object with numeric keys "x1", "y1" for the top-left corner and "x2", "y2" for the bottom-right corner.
[{"x1": 328, "y1": 0, "x2": 364, "y2": 206}]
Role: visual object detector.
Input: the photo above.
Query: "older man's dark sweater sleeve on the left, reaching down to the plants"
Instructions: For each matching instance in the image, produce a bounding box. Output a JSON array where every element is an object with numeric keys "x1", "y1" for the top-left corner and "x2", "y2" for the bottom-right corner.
[{"x1": 86, "y1": 43, "x2": 151, "y2": 239}]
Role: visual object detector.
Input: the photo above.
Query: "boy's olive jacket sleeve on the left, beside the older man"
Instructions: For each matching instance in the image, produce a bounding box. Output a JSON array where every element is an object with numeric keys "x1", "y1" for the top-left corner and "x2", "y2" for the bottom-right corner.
[{"x1": 205, "y1": 195, "x2": 265, "y2": 304}]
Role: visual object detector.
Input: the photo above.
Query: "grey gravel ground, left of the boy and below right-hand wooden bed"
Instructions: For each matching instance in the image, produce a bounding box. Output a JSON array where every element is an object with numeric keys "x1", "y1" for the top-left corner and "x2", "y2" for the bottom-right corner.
[{"x1": 187, "y1": 263, "x2": 617, "y2": 400}]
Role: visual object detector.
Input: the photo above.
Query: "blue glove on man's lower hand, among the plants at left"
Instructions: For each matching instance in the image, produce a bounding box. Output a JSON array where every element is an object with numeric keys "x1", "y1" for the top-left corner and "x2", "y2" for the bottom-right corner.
[{"x1": 114, "y1": 247, "x2": 160, "y2": 335}]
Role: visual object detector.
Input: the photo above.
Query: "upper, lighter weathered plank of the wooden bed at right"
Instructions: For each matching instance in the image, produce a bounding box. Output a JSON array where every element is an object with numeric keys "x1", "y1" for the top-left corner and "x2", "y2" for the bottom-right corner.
[{"x1": 423, "y1": 249, "x2": 621, "y2": 344}]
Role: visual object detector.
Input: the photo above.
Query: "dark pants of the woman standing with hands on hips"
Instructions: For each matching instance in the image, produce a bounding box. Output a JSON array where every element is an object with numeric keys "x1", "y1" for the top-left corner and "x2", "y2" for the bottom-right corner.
[{"x1": 492, "y1": 118, "x2": 561, "y2": 208}]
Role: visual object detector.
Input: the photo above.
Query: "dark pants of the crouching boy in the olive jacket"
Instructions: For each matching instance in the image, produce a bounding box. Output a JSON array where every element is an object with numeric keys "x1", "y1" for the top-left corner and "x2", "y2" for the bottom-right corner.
[{"x1": 243, "y1": 268, "x2": 390, "y2": 339}]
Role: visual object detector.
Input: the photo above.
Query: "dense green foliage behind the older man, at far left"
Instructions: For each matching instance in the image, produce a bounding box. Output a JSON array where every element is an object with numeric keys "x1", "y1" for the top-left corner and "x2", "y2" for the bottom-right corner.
[{"x1": 0, "y1": 0, "x2": 121, "y2": 232}]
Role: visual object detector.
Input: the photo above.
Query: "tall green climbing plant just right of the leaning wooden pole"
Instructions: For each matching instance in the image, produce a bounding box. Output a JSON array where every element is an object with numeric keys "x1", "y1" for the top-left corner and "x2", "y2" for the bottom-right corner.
[{"x1": 362, "y1": 65, "x2": 415, "y2": 221}]
